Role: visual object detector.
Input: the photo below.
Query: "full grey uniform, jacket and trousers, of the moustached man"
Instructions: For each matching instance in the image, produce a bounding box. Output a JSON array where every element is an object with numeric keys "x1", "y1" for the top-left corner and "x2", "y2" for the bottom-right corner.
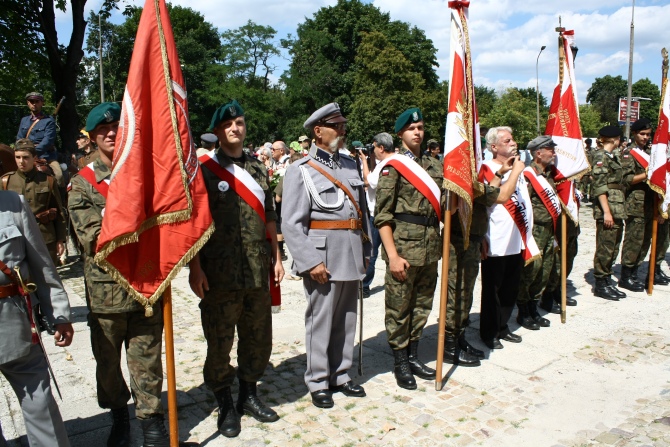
[{"x1": 282, "y1": 146, "x2": 371, "y2": 392}]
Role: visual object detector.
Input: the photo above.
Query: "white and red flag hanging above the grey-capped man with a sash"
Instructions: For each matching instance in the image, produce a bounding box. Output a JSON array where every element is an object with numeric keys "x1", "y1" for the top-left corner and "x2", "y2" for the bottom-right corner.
[{"x1": 544, "y1": 30, "x2": 590, "y2": 222}]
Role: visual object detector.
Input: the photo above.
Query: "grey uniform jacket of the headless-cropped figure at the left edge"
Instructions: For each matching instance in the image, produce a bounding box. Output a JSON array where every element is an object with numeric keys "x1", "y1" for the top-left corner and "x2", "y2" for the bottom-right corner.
[{"x1": 0, "y1": 191, "x2": 70, "y2": 365}]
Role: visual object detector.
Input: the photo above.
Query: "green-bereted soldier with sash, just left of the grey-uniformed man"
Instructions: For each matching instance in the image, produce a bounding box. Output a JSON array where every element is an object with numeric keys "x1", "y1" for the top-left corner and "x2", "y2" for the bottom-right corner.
[{"x1": 189, "y1": 101, "x2": 284, "y2": 438}]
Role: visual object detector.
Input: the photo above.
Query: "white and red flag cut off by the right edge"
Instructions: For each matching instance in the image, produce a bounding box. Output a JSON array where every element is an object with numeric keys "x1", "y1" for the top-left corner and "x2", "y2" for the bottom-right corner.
[{"x1": 647, "y1": 63, "x2": 670, "y2": 213}]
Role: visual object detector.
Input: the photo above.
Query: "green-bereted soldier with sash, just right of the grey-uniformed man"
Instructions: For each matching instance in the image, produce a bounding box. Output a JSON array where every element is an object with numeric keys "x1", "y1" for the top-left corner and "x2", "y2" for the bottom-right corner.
[{"x1": 374, "y1": 108, "x2": 444, "y2": 390}]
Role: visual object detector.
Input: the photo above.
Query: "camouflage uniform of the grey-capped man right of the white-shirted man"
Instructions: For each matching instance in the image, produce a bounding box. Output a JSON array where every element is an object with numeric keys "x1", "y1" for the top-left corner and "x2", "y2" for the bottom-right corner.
[{"x1": 516, "y1": 162, "x2": 556, "y2": 306}]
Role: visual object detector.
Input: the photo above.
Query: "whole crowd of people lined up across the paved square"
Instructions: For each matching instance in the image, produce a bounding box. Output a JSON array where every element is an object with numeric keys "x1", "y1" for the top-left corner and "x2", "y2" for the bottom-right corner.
[{"x1": 0, "y1": 92, "x2": 670, "y2": 447}]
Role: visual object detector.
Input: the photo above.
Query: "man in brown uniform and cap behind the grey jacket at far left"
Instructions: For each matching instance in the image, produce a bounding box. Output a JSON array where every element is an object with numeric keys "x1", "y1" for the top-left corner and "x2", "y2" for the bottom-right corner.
[{"x1": 2, "y1": 138, "x2": 66, "y2": 265}]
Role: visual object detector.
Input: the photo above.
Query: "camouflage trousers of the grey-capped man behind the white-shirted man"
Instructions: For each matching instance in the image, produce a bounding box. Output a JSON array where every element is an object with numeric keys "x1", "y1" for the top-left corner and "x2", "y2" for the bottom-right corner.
[{"x1": 516, "y1": 224, "x2": 556, "y2": 305}]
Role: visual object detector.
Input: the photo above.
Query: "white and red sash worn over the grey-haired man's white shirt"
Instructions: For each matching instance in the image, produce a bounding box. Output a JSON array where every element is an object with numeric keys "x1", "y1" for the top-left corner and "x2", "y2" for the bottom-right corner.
[{"x1": 479, "y1": 161, "x2": 541, "y2": 265}]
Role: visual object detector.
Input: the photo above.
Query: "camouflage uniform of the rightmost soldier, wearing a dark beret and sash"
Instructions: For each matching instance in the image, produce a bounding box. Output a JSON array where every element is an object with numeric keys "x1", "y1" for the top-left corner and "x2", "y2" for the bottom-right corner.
[{"x1": 621, "y1": 149, "x2": 654, "y2": 269}]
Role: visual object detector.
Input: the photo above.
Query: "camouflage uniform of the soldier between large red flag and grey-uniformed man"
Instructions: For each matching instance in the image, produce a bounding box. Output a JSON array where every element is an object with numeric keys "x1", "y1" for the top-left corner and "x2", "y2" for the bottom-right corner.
[{"x1": 200, "y1": 149, "x2": 277, "y2": 392}]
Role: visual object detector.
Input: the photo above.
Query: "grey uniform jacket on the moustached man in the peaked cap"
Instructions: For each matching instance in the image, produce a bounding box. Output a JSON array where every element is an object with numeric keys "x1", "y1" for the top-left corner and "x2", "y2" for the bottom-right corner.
[{"x1": 281, "y1": 146, "x2": 372, "y2": 281}]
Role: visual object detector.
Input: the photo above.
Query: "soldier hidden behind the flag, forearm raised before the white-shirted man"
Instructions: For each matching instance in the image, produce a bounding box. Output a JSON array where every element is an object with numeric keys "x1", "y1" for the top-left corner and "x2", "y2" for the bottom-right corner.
[{"x1": 444, "y1": 158, "x2": 526, "y2": 366}]
